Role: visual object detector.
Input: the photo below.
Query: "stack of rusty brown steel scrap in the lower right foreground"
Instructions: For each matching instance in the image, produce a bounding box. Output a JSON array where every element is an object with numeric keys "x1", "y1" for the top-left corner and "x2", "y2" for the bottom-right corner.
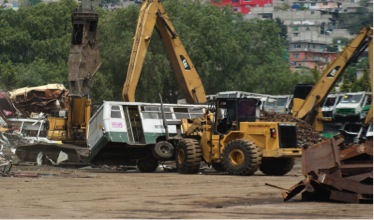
[{"x1": 283, "y1": 136, "x2": 373, "y2": 203}]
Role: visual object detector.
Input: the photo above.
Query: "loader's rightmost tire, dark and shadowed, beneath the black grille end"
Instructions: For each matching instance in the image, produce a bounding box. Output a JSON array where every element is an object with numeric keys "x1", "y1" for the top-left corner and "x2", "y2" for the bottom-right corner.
[{"x1": 260, "y1": 157, "x2": 295, "y2": 176}]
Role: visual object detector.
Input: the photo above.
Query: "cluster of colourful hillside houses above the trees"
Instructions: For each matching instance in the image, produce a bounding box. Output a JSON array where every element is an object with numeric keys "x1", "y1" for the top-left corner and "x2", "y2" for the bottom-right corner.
[{"x1": 211, "y1": 0, "x2": 359, "y2": 71}]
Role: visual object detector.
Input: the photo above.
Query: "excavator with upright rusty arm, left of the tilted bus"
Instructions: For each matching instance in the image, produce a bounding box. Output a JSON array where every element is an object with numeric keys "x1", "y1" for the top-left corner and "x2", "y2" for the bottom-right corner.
[{"x1": 16, "y1": 0, "x2": 101, "y2": 162}]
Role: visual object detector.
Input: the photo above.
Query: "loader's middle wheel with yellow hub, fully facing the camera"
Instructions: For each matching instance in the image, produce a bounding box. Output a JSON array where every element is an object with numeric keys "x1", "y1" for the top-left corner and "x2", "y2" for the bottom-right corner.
[{"x1": 223, "y1": 139, "x2": 262, "y2": 176}]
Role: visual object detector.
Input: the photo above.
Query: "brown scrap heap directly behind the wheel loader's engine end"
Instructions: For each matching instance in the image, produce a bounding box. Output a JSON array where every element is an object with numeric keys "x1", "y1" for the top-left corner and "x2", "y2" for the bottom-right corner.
[{"x1": 260, "y1": 111, "x2": 326, "y2": 146}]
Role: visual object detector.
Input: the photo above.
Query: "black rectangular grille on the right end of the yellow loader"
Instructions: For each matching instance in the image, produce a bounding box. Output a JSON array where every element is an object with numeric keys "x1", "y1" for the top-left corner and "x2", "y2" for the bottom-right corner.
[{"x1": 278, "y1": 124, "x2": 297, "y2": 148}]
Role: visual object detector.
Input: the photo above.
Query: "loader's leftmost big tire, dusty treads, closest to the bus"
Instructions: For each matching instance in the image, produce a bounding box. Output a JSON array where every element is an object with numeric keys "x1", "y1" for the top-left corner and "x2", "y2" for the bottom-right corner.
[{"x1": 175, "y1": 138, "x2": 202, "y2": 174}]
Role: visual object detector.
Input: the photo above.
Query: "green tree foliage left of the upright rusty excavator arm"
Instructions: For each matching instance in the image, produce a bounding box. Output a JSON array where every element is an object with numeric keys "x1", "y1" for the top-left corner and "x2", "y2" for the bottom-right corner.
[{"x1": 0, "y1": 0, "x2": 77, "y2": 89}]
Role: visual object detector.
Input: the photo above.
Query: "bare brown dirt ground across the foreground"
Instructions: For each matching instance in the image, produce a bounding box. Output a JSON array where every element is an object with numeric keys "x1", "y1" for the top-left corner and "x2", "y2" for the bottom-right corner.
[{"x1": 0, "y1": 160, "x2": 373, "y2": 219}]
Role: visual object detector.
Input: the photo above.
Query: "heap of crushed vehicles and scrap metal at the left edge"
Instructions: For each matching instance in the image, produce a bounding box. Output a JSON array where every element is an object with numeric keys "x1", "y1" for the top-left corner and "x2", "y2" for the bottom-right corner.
[{"x1": 0, "y1": 84, "x2": 87, "y2": 166}]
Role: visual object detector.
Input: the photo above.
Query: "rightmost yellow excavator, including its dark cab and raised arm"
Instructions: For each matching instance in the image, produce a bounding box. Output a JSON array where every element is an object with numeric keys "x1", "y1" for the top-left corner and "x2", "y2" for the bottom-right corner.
[{"x1": 292, "y1": 27, "x2": 373, "y2": 131}]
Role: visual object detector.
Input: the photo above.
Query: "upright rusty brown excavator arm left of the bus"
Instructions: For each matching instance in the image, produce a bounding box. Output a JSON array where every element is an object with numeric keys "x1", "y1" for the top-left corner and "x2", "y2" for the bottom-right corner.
[{"x1": 65, "y1": 0, "x2": 101, "y2": 140}]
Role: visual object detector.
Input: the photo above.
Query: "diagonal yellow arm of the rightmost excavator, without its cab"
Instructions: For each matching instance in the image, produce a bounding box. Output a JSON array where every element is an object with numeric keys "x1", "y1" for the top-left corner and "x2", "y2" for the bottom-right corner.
[{"x1": 293, "y1": 27, "x2": 373, "y2": 131}]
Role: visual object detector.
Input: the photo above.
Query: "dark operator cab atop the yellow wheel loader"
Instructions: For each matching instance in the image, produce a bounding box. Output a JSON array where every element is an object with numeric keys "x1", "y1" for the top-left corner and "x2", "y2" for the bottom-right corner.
[{"x1": 214, "y1": 98, "x2": 261, "y2": 134}]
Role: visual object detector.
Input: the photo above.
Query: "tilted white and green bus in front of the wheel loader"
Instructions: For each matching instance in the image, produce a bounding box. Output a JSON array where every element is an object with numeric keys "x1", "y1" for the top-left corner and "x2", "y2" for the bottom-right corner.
[{"x1": 87, "y1": 101, "x2": 207, "y2": 172}]
